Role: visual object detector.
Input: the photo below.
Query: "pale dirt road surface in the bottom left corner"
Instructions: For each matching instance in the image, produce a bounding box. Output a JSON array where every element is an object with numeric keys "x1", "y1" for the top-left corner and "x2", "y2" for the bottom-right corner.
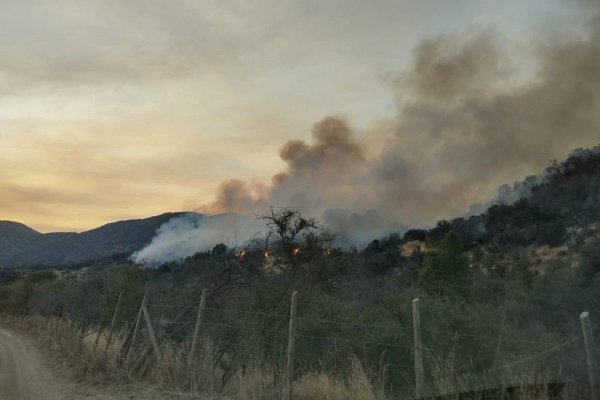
[{"x1": 0, "y1": 328, "x2": 68, "y2": 400}]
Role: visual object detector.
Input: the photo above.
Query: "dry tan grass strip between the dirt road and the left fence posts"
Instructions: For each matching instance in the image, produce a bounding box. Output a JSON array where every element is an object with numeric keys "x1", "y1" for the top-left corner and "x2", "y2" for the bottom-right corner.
[{"x1": 2, "y1": 316, "x2": 392, "y2": 400}]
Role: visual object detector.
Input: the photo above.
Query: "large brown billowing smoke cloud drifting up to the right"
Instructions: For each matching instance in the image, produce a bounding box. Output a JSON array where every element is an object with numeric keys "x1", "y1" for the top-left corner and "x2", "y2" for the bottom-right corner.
[{"x1": 136, "y1": 7, "x2": 600, "y2": 264}]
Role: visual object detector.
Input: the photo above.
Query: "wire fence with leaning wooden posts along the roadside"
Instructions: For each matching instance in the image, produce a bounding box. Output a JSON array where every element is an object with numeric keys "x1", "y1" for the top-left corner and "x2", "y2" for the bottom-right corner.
[{"x1": 18, "y1": 289, "x2": 598, "y2": 400}]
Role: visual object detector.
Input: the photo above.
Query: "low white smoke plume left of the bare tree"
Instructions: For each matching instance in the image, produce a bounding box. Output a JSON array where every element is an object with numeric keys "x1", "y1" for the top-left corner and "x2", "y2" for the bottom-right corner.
[{"x1": 131, "y1": 213, "x2": 266, "y2": 267}]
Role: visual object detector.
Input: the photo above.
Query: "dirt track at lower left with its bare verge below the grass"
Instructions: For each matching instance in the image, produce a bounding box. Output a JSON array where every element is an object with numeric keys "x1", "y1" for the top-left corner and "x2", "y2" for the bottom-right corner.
[{"x1": 0, "y1": 327, "x2": 188, "y2": 400}]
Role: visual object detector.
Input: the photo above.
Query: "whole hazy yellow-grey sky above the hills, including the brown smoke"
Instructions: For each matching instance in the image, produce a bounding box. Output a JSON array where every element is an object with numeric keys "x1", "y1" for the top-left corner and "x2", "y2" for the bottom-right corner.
[{"x1": 0, "y1": 0, "x2": 600, "y2": 232}]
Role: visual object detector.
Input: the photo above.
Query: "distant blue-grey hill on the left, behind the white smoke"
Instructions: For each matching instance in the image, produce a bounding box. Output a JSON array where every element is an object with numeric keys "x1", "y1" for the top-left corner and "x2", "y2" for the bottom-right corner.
[{"x1": 0, "y1": 213, "x2": 192, "y2": 267}]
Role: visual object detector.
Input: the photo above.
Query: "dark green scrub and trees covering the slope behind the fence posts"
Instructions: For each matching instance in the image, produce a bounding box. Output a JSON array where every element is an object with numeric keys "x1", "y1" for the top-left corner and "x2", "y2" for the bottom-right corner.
[{"x1": 0, "y1": 151, "x2": 600, "y2": 399}]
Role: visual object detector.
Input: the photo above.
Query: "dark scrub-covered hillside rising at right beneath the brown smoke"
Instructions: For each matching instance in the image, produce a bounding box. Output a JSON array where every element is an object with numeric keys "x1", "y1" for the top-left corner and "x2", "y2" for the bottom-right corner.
[{"x1": 362, "y1": 147, "x2": 600, "y2": 284}]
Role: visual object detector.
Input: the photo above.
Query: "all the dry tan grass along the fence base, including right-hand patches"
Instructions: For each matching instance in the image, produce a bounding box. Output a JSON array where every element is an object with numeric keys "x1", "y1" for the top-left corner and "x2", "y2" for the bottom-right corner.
[{"x1": 2, "y1": 316, "x2": 580, "y2": 400}]
